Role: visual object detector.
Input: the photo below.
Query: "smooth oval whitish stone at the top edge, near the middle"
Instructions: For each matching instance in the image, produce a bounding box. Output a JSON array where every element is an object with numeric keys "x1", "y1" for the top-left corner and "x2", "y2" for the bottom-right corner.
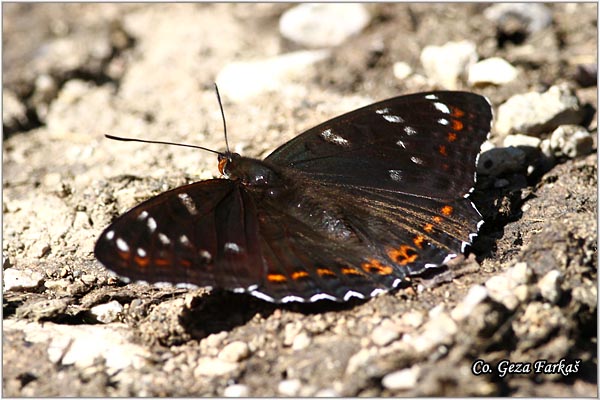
[{"x1": 279, "y1": 3, "x2": 371, "y2": 48}]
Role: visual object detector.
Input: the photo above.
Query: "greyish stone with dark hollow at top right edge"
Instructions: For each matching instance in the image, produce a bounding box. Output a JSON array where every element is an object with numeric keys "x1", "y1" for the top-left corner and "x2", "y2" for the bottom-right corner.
[{"x1": 483, "y1": 3, "x2": 552, "y2": 33}]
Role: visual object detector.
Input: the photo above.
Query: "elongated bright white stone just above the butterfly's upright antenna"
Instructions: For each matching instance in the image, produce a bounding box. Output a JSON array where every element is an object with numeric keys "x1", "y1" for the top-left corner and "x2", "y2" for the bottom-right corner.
[{"x1": 216, "y1": 50, "x2": 329, "y2": 102}]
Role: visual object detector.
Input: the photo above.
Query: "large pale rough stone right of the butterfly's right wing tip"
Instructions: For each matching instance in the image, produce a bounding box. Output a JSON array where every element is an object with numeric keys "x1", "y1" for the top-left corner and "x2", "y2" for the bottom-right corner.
[{"x1": 495, "y1": 85, "x2": 585, "y2": 136}]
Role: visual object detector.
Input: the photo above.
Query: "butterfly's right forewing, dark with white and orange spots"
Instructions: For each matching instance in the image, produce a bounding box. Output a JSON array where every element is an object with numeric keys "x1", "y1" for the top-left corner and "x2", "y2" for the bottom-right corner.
[{"x1": 265, "y1": 92, "x2": 492, "y2": 199}]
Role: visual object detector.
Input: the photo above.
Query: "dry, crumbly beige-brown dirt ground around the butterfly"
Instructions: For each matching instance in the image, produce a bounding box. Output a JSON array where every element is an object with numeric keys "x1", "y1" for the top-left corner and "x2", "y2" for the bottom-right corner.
[{"x1": 2, "y1": 3, "x2": 597, "y2": 397}]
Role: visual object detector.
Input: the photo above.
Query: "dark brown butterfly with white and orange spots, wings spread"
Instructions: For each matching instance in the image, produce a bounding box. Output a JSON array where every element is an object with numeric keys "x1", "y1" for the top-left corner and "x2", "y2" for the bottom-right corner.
[{"x1": 94, "y1": 91, "x2": 492, "y2": 303}]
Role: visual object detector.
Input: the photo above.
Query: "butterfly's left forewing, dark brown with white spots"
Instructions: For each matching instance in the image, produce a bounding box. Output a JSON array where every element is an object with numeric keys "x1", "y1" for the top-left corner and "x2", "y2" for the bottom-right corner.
[{"x1": 94, "y1": 179, "x2": 265, "y2": 290}]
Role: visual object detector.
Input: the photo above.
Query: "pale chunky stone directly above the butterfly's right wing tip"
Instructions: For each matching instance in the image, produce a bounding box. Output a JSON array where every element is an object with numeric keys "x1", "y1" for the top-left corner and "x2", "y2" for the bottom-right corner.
[{"x1": 421, "y1": 40, "x2": 478, "y2": 89}]
